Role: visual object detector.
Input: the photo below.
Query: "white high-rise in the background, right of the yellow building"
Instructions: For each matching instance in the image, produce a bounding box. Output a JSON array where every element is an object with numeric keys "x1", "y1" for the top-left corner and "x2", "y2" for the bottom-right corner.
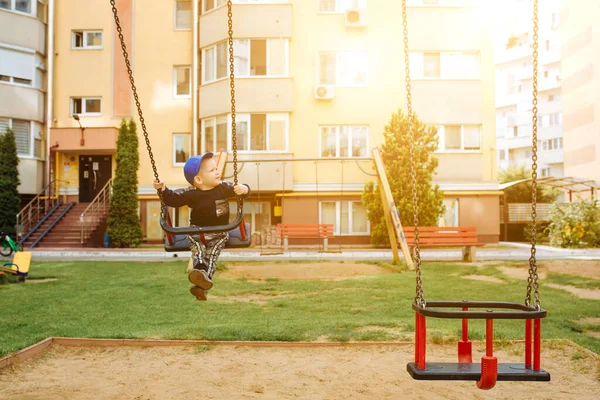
[{"x1": 495, "y1": 0, "x2": 564, "y2": 177}]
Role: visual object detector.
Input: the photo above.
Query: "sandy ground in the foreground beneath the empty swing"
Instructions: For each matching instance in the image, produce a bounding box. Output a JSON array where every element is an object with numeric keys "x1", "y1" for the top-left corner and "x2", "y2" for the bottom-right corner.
[{"x1": 0, "y1": 344, "x2": 600, "y2": 400}]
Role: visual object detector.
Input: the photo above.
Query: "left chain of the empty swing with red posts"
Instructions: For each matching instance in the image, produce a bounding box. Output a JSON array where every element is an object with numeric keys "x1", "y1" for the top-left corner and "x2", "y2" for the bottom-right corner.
[{"x1": 402, "y1": 0, "x2": 425, "y2": 306}]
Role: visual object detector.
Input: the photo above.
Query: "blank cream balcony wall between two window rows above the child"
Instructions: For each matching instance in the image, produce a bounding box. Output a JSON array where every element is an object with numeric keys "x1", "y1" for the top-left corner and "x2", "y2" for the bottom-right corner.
[{"x1": 198, "y1": 77, "x2": 293, "y2": 118}]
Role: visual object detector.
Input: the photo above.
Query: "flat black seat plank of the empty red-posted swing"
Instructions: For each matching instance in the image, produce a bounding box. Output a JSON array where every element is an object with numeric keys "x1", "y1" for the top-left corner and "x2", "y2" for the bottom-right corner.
[{"x1": 406, "y1": 362, "x2": 550, "y2": 382}]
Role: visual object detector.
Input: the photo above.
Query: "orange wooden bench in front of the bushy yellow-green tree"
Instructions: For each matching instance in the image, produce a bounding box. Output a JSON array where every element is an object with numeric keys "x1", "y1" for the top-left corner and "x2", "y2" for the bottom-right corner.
[{"x1": 404, "y1": 226, "x2": 485, "y2": 262}]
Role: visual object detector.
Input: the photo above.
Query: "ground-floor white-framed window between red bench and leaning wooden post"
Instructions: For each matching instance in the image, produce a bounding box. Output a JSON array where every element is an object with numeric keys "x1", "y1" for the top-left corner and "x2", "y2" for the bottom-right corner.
[{"x1": 319, "y1": 200, "x2": 370, "y2": 236}]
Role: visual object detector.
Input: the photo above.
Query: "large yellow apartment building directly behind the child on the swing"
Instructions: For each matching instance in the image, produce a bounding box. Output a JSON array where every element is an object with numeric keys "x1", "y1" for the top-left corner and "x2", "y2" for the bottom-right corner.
[{"x1": 51, "y1": 0, "x2": 501, "y2": 243}]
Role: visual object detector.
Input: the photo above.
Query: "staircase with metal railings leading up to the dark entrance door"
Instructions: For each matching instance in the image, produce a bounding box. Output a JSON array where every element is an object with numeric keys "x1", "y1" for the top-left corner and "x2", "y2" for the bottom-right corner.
[{"x1": 23, "y1": 203, "x2": 89, "y2": 250}]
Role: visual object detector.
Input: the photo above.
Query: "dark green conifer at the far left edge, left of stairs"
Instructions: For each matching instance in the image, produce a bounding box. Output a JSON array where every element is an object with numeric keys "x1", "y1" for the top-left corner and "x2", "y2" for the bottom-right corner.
[{"x1": 0, "y1": 129, "x2": 21, "y2": 237}]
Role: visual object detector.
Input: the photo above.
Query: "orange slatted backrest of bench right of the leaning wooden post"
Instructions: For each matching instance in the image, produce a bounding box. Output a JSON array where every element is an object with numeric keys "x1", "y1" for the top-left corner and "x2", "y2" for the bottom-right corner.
[{"x1": 403, "y1": 226, "x2": 480, "y2": 246}]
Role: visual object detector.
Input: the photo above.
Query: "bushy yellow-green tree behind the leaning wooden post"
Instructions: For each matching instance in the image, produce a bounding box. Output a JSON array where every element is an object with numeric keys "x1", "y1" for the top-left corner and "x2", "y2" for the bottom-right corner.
[{"x1": 362, "y1": 110, "x2": 444, "y2": 245}]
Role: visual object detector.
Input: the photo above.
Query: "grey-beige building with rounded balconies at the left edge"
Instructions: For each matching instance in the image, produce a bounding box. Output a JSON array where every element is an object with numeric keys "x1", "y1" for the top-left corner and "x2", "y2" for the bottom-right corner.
[{"x1": 0, "y1": 0, "x2": 47, "y2": 202}]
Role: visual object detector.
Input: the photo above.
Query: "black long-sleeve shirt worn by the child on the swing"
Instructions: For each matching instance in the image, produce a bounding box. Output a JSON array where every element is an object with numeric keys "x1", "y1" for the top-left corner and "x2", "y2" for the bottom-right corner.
[{"x1": 163, "y1": 182, "x2": 250, "y2": 226}]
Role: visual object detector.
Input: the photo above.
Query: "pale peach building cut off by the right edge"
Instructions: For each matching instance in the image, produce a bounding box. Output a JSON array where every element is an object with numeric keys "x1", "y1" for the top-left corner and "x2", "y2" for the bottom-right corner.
[{"x1": 560, "y1": 0, "x2": 600, "y2": 181}]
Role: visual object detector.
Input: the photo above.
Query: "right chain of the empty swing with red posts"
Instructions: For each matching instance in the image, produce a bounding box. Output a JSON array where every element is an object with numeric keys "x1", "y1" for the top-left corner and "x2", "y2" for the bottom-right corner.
[{"x1": 525, "y1": 0, "x2": 541, "y2": 309}]
